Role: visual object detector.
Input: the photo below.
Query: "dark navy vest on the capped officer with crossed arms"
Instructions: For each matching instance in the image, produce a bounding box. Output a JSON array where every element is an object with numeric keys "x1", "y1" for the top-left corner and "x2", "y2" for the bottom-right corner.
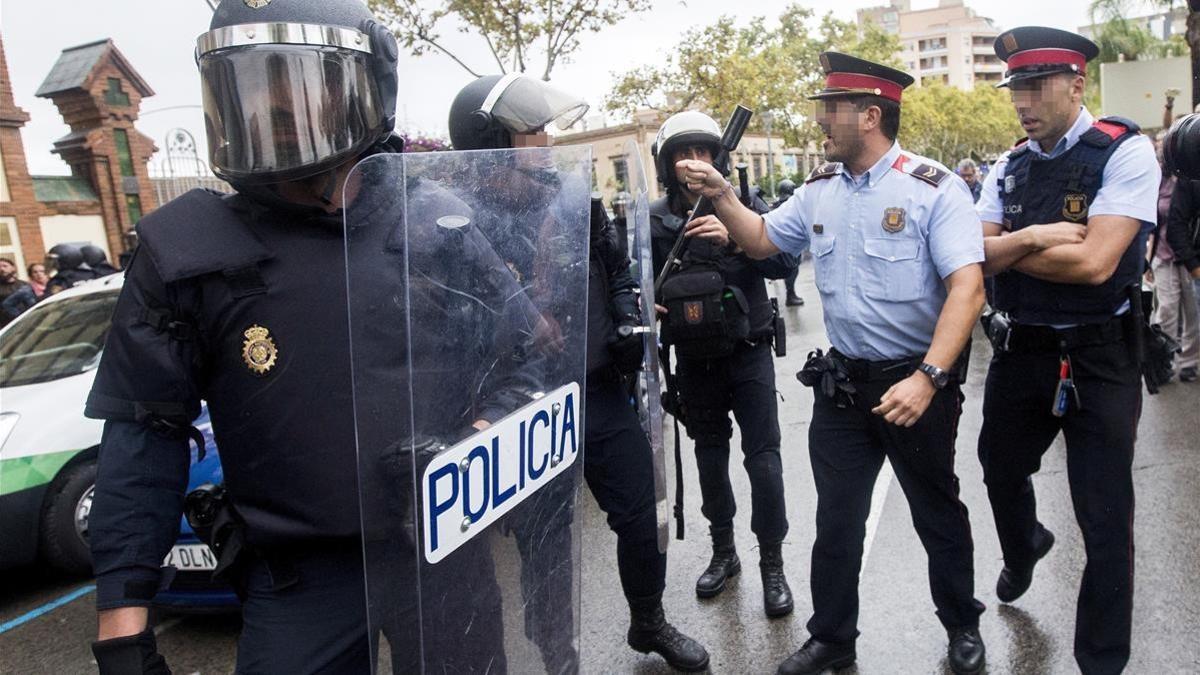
[{"x1": 996, "y1": 118, "x2": 1145, "y2": 324}]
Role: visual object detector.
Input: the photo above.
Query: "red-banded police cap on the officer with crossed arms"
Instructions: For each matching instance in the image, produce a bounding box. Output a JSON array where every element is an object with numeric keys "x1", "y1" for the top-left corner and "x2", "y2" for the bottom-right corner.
[{"x1": 994, "y1": 25, "x2": 1100, "y2": 86}]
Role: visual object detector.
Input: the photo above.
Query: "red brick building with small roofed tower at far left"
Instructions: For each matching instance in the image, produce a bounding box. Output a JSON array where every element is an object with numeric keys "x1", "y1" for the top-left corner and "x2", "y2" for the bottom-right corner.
[{"x1": 0, "y1": 33, "x2": 157, "y2": 276}]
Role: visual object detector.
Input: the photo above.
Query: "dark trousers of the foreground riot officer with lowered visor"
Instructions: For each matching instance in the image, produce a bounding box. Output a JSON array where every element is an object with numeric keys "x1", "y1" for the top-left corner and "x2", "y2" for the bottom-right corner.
[{"x1": 236, "y1": 542, "x2": 506, "y2": 675}]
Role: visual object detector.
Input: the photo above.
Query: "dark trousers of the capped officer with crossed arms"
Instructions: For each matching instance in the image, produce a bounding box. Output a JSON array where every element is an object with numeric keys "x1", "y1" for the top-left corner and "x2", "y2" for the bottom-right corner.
[{"x1": 979, "y1": 342, "x2": 1141, "y2": 674}]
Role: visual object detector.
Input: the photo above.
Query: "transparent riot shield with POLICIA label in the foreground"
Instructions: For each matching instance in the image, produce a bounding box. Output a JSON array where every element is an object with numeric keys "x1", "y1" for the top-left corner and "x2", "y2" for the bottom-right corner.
[{"x1": 346, "y1": 148, "x2": 592, "y2": 674}]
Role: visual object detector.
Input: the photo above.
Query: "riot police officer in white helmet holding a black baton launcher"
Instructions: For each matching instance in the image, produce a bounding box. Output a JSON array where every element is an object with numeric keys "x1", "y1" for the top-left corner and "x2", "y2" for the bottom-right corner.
[{"x1": 650, "y1": 110, "x2": 796, "y2": 617}]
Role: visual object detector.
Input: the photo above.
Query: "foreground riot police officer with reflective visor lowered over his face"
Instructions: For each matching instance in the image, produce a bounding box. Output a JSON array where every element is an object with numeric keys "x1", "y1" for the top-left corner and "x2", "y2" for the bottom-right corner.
[{"x1": 85, "y1": 0, "x2": 528, "y2": 674}]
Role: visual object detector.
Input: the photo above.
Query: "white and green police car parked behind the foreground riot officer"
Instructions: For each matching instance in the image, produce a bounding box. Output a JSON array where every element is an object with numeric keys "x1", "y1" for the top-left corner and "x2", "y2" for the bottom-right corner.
[{"x1": 0, "y1": 274, "x2": 238, "y2": 609}]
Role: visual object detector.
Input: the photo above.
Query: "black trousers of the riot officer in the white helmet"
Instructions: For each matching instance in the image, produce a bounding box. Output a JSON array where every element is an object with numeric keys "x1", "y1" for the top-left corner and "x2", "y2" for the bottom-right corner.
[{"x1": 677, "y1": 342, "x2": 787, "y2": 544}]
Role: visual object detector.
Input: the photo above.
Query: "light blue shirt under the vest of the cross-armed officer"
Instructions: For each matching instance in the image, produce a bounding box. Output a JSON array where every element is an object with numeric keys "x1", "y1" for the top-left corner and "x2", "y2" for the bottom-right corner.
[{"x1": 976, "y1": 108, "x2": 1163, "y2": 227}]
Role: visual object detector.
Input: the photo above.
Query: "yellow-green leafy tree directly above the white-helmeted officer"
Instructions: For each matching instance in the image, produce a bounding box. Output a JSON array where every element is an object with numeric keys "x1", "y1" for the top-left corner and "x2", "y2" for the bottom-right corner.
[{"x1": 605, "y1": 5, "x2": 900, "y2": 145}]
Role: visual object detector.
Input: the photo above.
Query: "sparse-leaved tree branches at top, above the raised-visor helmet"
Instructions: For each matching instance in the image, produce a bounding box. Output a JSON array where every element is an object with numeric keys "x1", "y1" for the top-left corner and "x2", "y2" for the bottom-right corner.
[{"x1": 367, "y1": 0, "x2": 650, "y2": 79}]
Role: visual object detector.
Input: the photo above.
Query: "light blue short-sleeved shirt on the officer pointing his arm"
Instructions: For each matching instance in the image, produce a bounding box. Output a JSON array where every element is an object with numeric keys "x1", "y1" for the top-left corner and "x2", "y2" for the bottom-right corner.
[{"x1": 763, "y1": 144, "x2": 984, "y2": 360}]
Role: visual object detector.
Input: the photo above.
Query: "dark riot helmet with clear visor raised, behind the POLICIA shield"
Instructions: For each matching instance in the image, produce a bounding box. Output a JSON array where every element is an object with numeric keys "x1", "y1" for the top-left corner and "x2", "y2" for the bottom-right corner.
[{"x1": 449, "y1": 73, "x2": 588, "y2": 150}]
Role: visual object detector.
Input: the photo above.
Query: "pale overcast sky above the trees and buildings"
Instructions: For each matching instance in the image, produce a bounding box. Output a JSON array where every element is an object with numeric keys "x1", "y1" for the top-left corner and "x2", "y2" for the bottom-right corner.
[{"x1": 0, "y1": 0, "x2": 1123, "y2": 174}]
